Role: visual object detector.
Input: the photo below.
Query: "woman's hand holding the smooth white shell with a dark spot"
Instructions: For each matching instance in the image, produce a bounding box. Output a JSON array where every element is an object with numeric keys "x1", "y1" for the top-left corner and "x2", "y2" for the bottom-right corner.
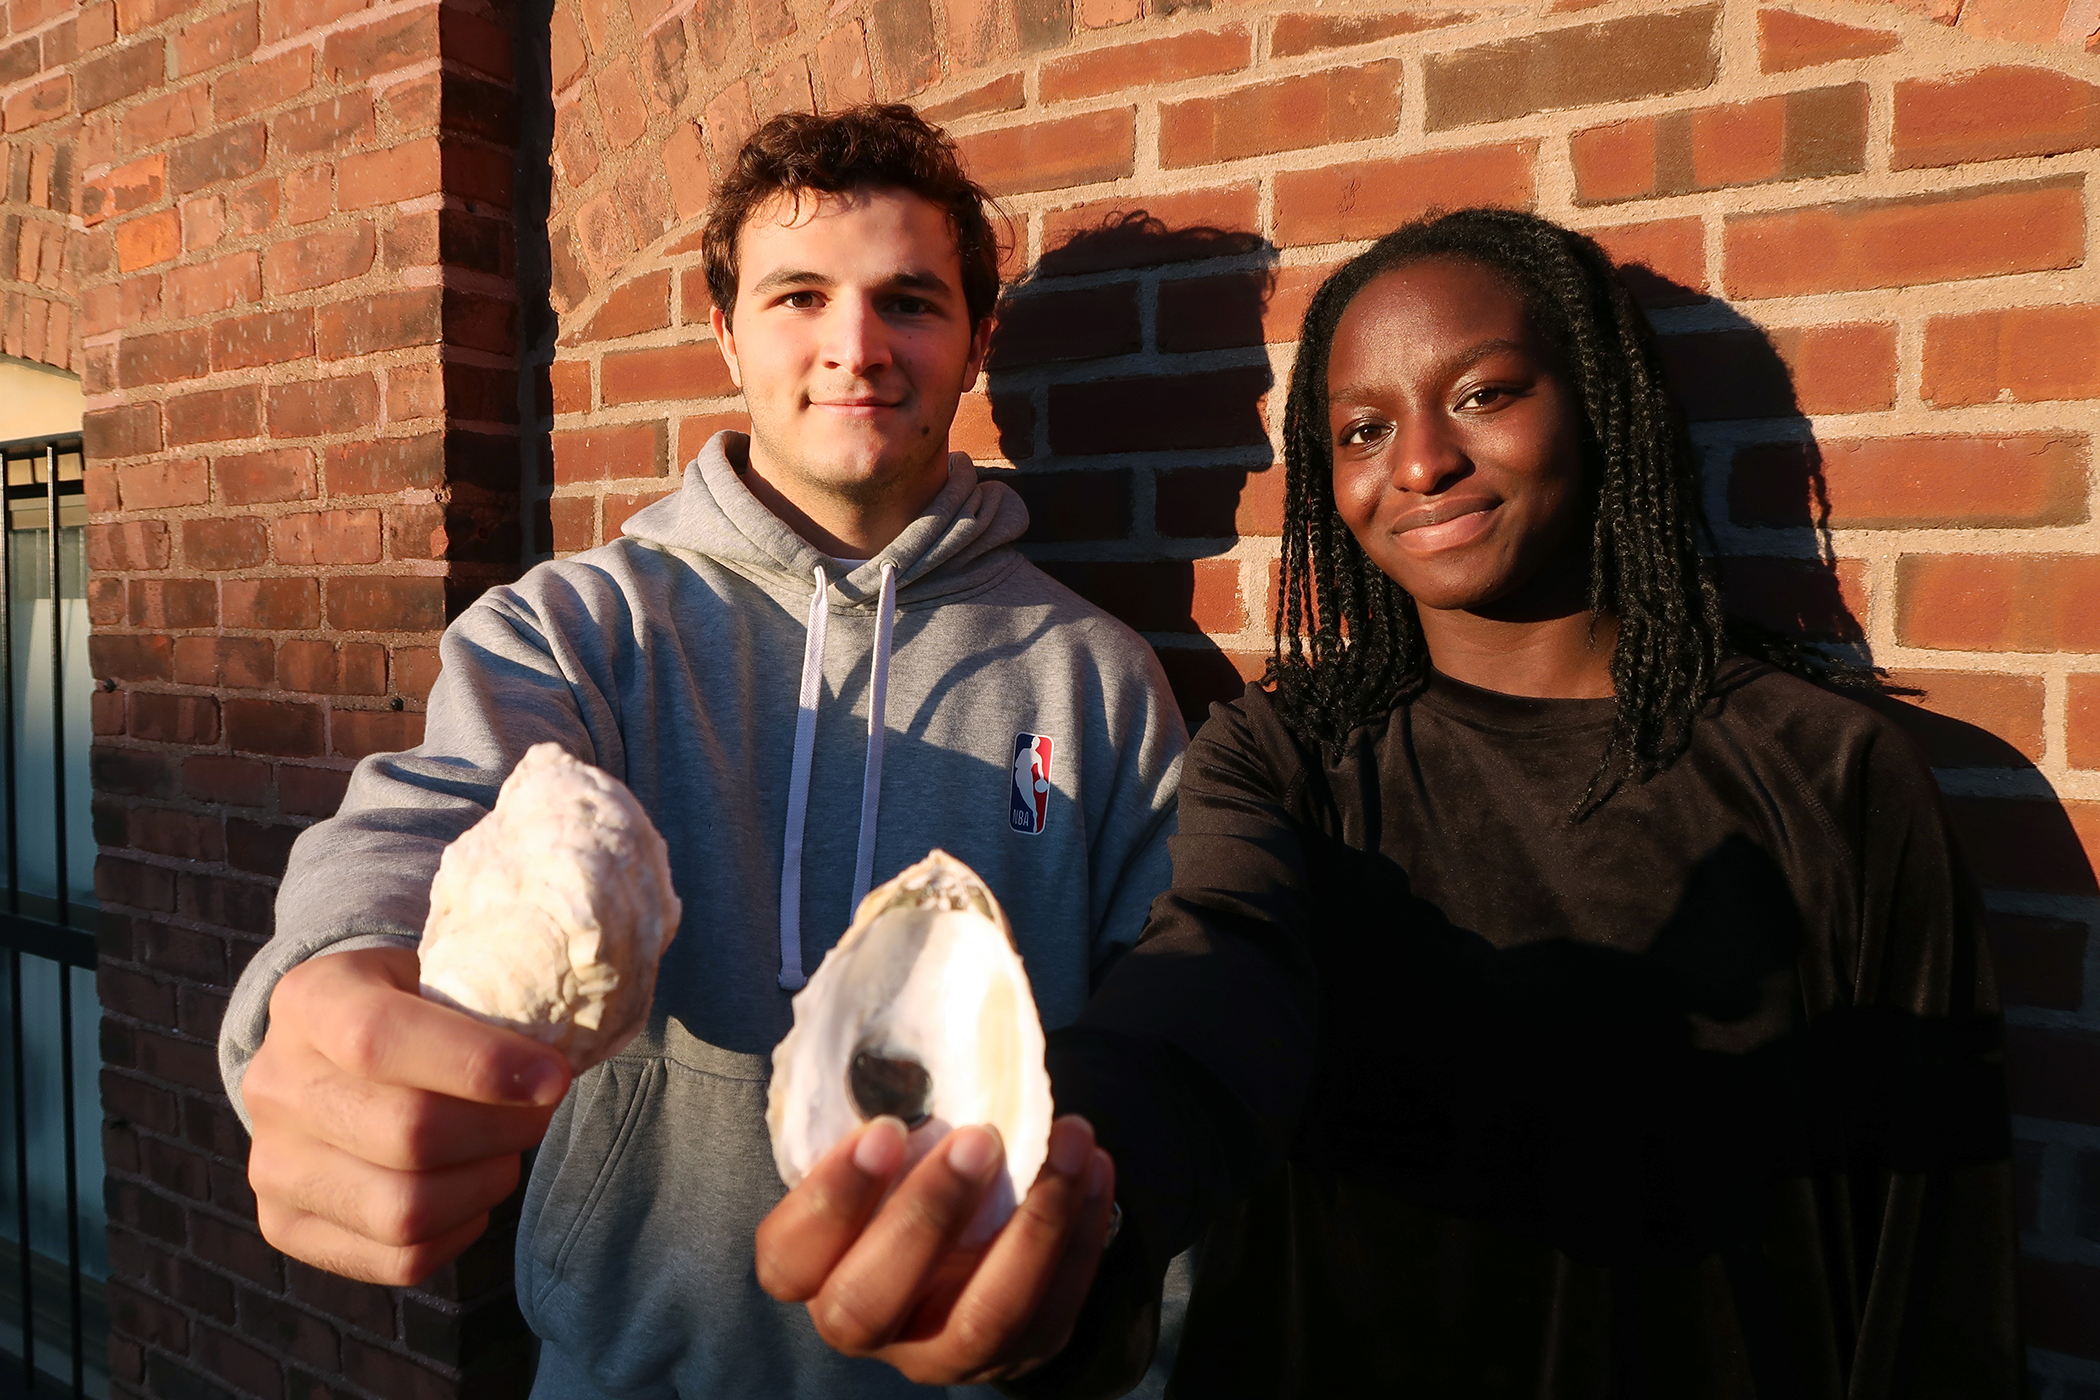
[{"x1": 758, "y1": 1117, "x2": 1115, "y2": 1385}]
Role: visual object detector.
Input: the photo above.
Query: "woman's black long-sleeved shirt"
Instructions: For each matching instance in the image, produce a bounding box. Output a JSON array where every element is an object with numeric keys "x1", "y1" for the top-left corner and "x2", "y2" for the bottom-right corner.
[{"x1": 1021, "y1": 661, "x2": 2022, "y2": 1400}]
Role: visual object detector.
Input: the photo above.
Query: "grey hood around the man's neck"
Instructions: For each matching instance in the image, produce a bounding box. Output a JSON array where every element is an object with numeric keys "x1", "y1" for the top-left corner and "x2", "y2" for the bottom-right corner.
[{"x1": 622, "y1": 430, "x2": 1029, "y2": 607}]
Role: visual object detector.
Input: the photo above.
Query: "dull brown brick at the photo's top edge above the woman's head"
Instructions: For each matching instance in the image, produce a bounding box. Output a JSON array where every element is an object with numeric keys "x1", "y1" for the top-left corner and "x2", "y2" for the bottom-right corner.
[{"x1": 1422, "y1": 6, "x2": 1720, "y2": 131}]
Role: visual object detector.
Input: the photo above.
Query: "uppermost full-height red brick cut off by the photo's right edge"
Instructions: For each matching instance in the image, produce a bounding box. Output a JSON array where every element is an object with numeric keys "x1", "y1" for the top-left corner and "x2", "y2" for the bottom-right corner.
[{"x1": 1890, "y1": 67, "x2": 2100, "y2": 170}]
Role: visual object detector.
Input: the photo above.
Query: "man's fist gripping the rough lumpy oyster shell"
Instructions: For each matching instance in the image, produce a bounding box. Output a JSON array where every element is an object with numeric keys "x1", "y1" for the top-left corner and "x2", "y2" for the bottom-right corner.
[{"x1": 242, "y1": 949, "x2": 569, "y2": 1285}]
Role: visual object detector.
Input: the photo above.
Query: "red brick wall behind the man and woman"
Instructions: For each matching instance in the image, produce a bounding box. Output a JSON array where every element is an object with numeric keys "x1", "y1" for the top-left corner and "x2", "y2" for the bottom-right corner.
[{"x1": 12, "y1": 0, "x2": 2100, "y2": 1400}]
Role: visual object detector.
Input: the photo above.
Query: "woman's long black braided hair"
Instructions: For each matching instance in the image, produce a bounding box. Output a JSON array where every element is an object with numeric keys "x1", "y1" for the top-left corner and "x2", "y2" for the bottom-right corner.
[{"x1": 1266, "y1": 210, "x2": 1829, "y2": 819}]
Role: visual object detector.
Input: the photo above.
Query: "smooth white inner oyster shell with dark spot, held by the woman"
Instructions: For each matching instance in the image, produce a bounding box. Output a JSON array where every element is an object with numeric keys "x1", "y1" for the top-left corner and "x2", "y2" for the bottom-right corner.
[{"x1": 767, "y1": 850, "x2": 1052, "y2": 1238}]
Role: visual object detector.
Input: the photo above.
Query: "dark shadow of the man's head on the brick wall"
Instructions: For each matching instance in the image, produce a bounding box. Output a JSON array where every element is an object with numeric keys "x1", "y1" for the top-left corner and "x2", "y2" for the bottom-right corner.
[{"x1": 987, "y1": 210, "x2": 1296, "y2": 724}]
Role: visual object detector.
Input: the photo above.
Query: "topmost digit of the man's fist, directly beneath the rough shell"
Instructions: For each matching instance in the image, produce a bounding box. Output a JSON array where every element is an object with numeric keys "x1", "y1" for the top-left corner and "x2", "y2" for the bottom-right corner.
[{"x1": 271, "y1": 949, "x2": 569, "y2": 1106}]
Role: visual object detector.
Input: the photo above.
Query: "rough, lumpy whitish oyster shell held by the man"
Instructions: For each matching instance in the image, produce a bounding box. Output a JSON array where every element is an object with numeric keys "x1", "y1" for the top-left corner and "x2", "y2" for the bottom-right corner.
[{"x1": 418, "y1": 743, "x2": 678, "y2": 1070}]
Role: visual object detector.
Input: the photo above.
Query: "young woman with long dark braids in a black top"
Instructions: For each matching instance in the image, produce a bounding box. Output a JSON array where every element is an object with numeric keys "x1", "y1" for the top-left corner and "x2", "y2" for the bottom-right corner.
[{"x1": 1019, "y1": 210, "x2": 2022, "y2": 1400}]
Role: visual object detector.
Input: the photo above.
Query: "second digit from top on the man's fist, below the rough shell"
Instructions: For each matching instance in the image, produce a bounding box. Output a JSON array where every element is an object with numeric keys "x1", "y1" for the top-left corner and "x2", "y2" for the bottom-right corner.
[{"x1": 242, "y1": 1045, "x2": 554, "y2": 1171}]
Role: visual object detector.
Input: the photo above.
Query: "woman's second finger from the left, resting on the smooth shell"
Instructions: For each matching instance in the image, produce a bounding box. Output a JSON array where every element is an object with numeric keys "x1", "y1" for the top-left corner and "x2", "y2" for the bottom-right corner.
[{"x1": 809, "y1": 1127, "x2": 1006, "y2": 1356}]
